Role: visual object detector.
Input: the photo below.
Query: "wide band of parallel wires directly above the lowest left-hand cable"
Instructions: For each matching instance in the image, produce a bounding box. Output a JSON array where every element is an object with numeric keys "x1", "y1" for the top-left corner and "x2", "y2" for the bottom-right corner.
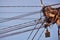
[{"x1": 0, "y1": 20, "x2": 41, "y2": 34}]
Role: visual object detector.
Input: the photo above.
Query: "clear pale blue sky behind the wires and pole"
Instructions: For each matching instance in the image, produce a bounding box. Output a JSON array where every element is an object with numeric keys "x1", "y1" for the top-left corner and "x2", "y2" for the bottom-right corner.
[{"x1": 0, "y1": 0, "x2": 60, "y2": 40}]
